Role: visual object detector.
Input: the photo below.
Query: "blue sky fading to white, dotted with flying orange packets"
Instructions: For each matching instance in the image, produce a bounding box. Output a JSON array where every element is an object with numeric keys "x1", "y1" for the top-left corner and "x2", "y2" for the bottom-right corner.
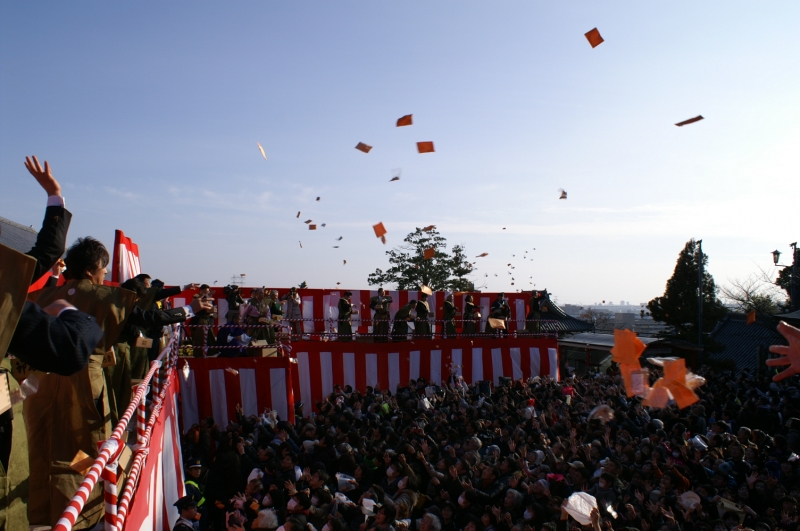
[{"x1": 0, "y1": 0, "x2": 800, "y2": 304}]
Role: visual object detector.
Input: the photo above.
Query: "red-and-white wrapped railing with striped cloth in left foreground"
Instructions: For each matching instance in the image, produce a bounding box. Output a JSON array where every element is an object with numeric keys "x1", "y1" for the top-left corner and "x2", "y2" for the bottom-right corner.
[{"x1": 53, "y1": 329, "x2": 185, "y2": 531}]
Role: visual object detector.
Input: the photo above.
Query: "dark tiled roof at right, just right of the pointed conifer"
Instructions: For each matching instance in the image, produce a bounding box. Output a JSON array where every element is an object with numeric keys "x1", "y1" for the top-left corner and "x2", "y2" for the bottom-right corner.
[{"x1": 709, "y1": 313, "x2": 787, "y2": 370}]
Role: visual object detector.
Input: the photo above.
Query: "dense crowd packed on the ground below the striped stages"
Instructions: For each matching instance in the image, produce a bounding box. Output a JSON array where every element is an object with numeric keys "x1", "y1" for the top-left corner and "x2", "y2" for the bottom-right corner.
[{"x1": 178, "y1": 358, "x2": 800, "y2": 531}]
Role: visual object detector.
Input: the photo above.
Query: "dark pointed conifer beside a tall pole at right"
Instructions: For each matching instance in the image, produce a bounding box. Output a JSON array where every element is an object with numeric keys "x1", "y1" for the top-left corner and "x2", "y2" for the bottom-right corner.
[{"x1": 647, "y1": 239, "x2": 726, "y2": 346}]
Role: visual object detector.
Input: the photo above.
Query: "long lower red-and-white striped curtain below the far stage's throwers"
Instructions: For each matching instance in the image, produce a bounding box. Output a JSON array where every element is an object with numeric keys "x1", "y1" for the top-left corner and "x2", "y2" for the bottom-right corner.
[{"x1": 290, "y1": 338, "x2": 559, "y2": 410}]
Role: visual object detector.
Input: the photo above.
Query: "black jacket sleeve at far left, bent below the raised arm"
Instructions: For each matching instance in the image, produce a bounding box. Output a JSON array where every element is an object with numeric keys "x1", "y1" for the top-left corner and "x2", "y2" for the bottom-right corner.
[{"x1": 8, "y1": 302, "x2": 103, "y2": 376}]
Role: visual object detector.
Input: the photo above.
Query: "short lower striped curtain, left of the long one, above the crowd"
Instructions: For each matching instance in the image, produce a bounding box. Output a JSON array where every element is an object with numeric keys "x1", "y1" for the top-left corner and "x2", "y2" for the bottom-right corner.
[{"x1": 178, "y1": 357, "x2": 294, "y2": 432}]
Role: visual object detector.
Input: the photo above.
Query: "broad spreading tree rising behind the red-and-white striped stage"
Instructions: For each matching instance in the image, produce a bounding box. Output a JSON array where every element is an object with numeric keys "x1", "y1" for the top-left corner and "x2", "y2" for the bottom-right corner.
[{"x1": 367, "y1": 228, "x2": 475, "y2": 291}]
